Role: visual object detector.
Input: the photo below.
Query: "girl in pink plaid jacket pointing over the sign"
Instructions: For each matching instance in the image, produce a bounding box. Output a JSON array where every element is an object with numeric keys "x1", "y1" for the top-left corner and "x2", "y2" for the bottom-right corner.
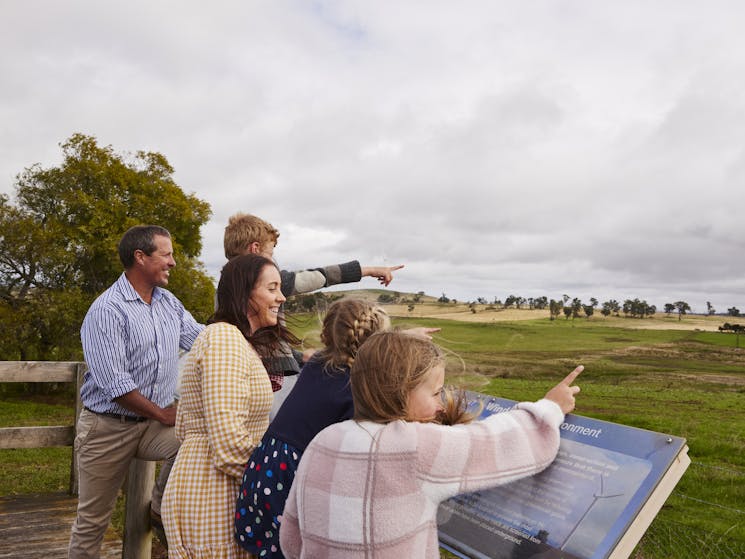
[{"x1": 280, "y1": 332, "x2": 582, "y2": 559}]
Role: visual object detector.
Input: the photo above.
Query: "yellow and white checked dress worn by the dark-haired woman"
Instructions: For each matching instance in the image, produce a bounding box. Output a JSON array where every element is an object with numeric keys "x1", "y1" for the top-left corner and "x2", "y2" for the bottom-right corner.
[{"x1": 162, "y1": 322, "x2": 272, "y2": 559}]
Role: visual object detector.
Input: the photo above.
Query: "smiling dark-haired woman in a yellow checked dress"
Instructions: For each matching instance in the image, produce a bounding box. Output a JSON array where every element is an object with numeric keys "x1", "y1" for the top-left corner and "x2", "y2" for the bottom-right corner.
[{"x1": 163, "y1": 254, "x2": 297, "y2": 559}]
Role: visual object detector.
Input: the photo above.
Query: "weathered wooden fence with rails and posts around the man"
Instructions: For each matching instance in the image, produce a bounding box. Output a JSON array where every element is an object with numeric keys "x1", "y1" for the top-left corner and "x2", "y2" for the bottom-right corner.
[{"x1": 0, "y1": 361, "x2": 155, "y2": 559}]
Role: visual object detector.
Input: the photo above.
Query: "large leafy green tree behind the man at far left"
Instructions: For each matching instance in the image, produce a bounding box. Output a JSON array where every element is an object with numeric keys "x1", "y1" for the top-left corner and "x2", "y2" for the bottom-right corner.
[{"x1": 0, "y1": 134, "x2": 214, "y2": 360}]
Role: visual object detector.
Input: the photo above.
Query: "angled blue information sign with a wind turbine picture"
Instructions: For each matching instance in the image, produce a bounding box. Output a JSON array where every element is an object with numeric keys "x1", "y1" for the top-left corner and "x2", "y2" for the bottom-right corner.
[{"x1": 438, "y1": 393, "x2": 690, "y2": 559}]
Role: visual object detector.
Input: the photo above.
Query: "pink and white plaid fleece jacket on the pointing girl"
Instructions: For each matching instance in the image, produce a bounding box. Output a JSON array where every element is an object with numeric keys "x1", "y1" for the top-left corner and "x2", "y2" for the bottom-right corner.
[{"x1": 279, "y1": 399, "x2": 564, "y2": 559}]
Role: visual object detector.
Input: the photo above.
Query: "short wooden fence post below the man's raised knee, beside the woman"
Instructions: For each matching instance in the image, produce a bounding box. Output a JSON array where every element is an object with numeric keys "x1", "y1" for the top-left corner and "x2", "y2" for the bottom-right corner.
[{"x1": 122, "y1": 459, "x2": 155, "y2": 559}]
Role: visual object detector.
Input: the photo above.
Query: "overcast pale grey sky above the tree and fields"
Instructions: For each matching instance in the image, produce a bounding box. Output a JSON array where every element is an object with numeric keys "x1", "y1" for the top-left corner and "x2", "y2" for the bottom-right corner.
[{"x1": 0, "y1": 0, "x2": 745, "y2": 312}]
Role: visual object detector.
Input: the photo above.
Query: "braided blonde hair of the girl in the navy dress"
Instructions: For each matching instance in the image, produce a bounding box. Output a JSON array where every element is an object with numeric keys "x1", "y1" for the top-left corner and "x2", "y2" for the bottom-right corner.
[{"x1": 318, "y1": 299, "x2": 391, "y2": 369}]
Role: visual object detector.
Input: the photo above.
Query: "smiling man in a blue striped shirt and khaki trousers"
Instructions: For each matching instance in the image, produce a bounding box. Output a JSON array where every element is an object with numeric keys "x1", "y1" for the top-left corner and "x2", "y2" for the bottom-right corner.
[{"x1": 69, "y1": 225, "x2": 203, "y2": 559}]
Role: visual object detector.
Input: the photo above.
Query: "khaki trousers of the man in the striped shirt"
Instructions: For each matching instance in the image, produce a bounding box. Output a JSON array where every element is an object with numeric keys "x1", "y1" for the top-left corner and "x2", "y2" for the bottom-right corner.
[{"x1": 69, "y1": 410, "x2": 179, "y2": 559}]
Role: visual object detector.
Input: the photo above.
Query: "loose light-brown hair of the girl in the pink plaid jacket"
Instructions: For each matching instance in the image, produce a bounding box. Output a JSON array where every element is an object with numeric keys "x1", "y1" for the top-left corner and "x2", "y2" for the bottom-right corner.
[{"x1": 351, "y1": 332, "x2": 444, "y2": 423}]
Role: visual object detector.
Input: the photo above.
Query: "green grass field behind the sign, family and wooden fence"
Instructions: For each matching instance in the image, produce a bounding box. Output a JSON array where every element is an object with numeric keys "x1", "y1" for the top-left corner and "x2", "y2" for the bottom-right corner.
[{"x1": 0, "y1": 316, "x2": 745, "y2": 558}]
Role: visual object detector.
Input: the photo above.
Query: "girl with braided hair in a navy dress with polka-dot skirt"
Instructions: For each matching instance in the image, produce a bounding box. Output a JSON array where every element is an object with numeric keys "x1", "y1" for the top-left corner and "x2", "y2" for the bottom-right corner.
[{"x1": 235, "y1": 299, "x2": 439, "y2": 559}]
